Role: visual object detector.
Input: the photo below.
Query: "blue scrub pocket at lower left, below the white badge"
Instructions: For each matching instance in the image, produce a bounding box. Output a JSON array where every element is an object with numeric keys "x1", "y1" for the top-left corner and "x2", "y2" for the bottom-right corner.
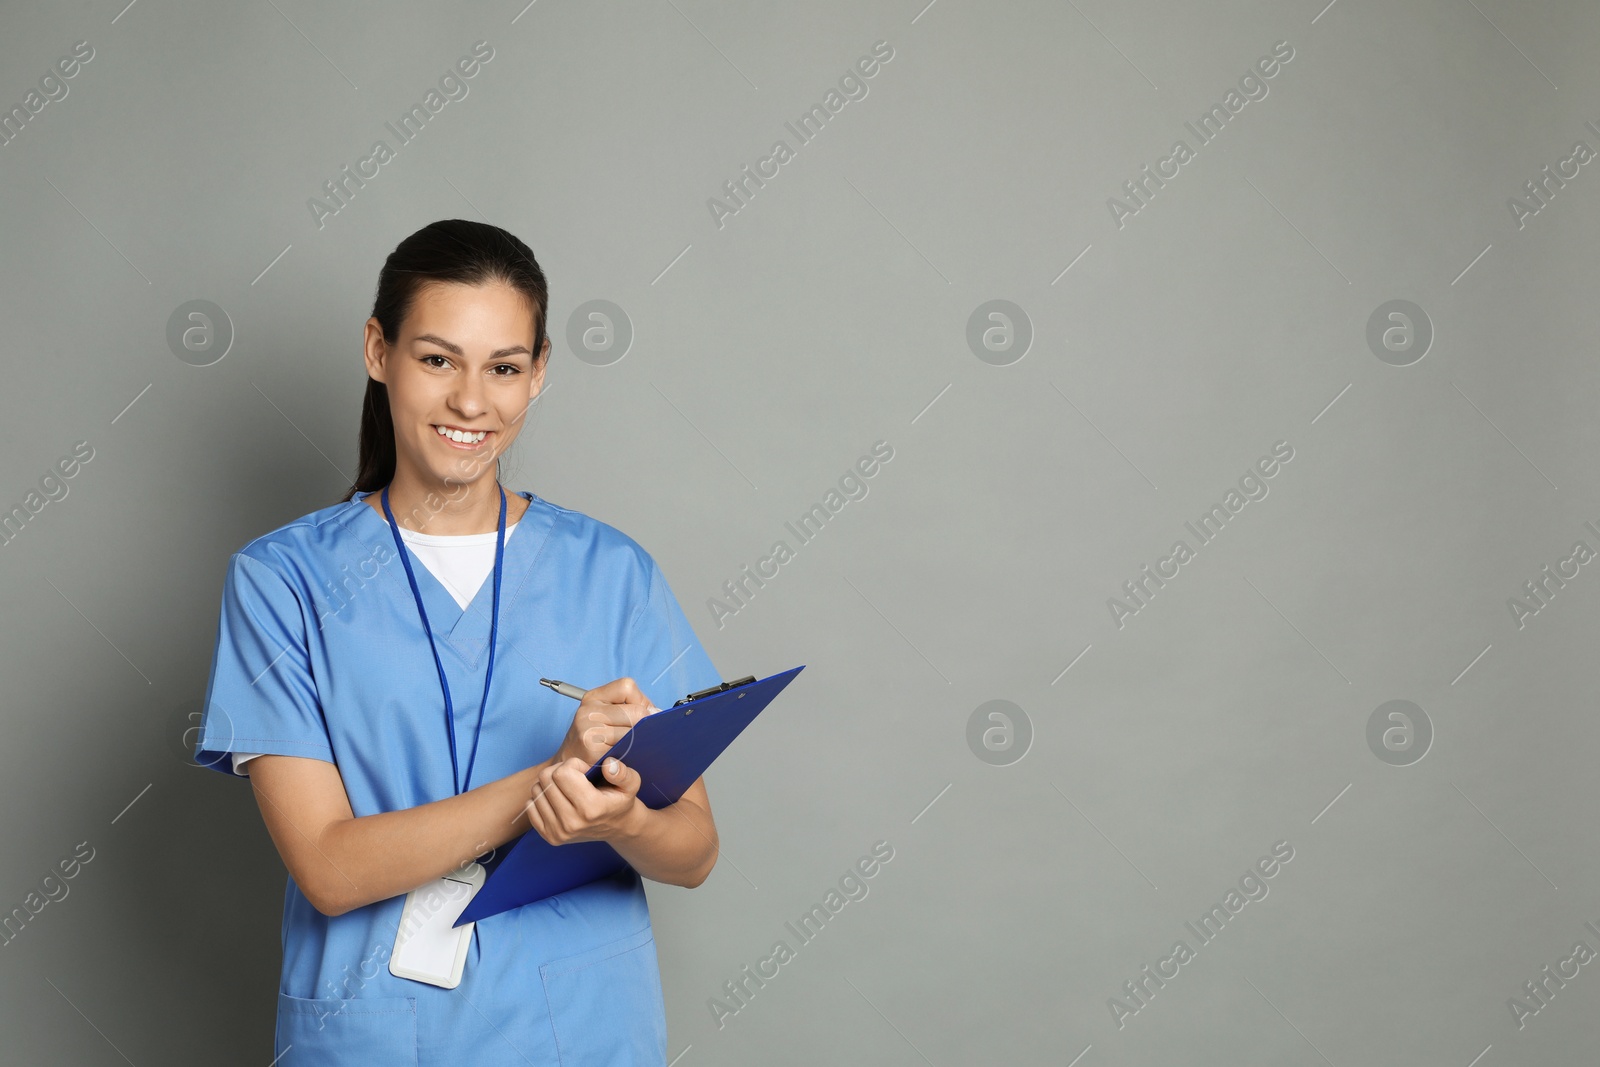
[{"x1": 274, "y1": 993, "x2": 418, "y2": 1067}]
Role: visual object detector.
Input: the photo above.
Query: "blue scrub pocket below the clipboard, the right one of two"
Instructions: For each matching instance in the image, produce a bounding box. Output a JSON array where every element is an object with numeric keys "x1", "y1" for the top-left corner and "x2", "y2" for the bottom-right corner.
[{"x1": 539, "y1": 926, "x2": 667, "y2": 1067}]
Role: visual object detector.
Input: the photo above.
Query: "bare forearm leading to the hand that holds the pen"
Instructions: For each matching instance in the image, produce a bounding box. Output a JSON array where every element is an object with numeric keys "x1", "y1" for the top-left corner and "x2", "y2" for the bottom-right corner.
[{"x1": 315, "y1": 763, "x2": 544, "y2": 915}]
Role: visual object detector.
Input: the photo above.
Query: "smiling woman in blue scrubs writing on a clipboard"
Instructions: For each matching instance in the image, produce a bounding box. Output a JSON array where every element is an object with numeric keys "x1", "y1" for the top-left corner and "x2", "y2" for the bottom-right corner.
[{"x1": 195, "y1": 219, "x2": 720, "y2": 1067}]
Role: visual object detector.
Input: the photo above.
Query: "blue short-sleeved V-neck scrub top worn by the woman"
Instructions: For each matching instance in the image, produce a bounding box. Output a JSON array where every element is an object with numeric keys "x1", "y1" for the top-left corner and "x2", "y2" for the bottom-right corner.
[{"x1": 195, "y1": 493, "x2": 722, "y2": 1067}]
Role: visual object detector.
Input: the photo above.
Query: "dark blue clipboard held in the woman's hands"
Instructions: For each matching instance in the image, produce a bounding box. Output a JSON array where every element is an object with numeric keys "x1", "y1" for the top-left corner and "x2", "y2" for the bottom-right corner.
[{"x1": 454, "y1": 664, "x2": 805, "y2": 926}]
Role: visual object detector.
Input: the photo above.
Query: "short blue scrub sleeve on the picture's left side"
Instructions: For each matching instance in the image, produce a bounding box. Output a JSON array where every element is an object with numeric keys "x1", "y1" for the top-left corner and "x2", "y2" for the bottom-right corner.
[{"x1": 195, "y1": 553, "x2": 333, "y2": 776}]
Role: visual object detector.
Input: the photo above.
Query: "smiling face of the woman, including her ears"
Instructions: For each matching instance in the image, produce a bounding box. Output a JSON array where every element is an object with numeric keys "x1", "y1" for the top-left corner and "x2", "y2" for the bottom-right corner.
[{"x1": 366, "y1": 282, "x2": 550, "y2": 483}]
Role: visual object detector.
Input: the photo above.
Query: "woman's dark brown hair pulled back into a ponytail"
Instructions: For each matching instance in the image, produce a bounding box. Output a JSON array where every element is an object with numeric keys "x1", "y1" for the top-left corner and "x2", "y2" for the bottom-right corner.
[{"x1": 342, "y1": 219, "x2": 550, "y2": 501}]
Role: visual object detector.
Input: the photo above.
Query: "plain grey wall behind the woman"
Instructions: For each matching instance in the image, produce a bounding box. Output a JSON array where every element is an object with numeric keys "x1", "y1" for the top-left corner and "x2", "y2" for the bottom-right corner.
[{"x1": 0, "y1": 0, "x2": 1600, "y2": 1067}]
